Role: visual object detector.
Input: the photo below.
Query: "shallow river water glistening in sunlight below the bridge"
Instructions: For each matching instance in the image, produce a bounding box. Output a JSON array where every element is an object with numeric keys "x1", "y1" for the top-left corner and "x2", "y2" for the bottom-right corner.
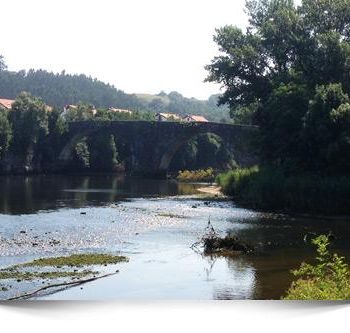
[{"x1": 0, "y1": 175, "x2": 350, "y2": 300}]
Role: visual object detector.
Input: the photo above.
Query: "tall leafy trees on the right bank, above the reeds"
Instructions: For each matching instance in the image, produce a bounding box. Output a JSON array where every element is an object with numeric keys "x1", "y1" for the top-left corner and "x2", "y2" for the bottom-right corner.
[{"x1": 207, "y1": 0, "x2": 350, "y2": 174}]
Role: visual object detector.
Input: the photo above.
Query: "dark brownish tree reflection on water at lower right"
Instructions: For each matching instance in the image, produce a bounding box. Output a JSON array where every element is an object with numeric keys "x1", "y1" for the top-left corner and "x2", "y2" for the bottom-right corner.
[{"x1": 218, "y1": 214, "x2": 350, "y2": 299}]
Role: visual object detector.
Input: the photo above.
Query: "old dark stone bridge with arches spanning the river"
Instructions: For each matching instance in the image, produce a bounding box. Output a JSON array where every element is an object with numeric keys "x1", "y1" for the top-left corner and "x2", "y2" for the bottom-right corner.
[{"x1": 59, "y1": 121, "x2": 258, "y2": 176}]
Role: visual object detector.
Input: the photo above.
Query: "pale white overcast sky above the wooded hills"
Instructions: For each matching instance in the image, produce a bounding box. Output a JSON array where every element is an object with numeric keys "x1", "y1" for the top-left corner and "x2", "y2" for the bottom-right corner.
[{"x1": 0, "y1": 0, "x2": 247, "y2": 99}]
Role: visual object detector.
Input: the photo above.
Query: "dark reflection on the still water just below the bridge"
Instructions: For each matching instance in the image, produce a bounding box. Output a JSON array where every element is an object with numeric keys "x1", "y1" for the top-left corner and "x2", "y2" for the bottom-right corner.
[{"x1": 0, "y1": 175, "x2": 198, "y2": 214}]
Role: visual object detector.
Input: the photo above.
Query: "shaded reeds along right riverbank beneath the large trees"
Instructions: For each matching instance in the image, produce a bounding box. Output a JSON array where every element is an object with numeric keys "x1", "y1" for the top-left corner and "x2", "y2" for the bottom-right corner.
[{"x1": 216, "y1": 166, "x2": 350, "y2": 215}]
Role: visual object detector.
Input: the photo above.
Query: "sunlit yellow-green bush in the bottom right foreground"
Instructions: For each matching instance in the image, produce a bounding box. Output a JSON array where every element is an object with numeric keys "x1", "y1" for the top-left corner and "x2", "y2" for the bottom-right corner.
[{"x1": 284, "y1": 235, "x2": 350, "y2": 300}]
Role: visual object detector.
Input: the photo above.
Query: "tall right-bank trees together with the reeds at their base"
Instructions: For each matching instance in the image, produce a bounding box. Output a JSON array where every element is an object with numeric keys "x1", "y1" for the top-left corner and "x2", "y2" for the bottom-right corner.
[{"x1": 207, "y1": 0, "x2": 350, "y2": 214}]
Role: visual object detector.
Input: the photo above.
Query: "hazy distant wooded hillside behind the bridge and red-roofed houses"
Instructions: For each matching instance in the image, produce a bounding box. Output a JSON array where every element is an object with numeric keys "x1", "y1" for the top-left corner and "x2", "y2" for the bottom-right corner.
[{"x1": 0, "y1": 63, "x2": 229, "y2": 122}]
